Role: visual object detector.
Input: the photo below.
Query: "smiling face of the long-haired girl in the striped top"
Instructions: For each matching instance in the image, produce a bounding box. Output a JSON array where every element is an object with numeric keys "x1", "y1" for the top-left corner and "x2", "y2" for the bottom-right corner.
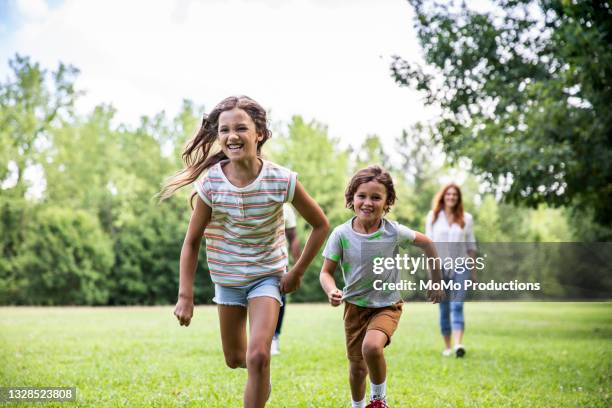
[{"x1": 218, "y1": 108, "x2": 263, "y2": 160}]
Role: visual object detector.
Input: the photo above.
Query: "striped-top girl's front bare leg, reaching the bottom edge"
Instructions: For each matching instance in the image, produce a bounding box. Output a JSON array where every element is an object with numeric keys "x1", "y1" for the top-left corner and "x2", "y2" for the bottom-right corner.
[{"x1": 244, "y1": 296, "x2": 280, "y2": 408}]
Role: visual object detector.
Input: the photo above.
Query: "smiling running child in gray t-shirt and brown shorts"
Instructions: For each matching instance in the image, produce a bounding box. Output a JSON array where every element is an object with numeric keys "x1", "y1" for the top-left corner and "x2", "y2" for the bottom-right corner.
[{"x1": 320, "y1": 166, "x2": 443, "y2": 408}]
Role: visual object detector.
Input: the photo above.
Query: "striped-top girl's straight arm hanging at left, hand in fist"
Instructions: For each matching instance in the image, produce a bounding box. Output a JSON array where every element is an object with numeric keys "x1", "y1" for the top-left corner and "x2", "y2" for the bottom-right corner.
[{"x1": 174, "y1": 197, "x2": 212, "y2": 326}]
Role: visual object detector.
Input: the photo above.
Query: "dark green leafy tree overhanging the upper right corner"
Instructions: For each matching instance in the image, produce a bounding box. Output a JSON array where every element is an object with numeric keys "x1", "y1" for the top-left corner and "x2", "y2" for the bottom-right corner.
[{"x1": 391, "y1": 0, "x2": 612, "y2": 239}]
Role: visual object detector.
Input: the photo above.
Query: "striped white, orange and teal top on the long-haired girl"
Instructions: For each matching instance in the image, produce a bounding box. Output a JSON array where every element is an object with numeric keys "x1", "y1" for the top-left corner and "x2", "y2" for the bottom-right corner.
[{"x1": 194, "y1": 160, "x2": 297, "y2": 286}]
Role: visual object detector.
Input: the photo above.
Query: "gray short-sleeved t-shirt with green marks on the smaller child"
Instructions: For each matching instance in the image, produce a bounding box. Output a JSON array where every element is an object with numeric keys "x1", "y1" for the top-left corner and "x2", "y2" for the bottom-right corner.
[{"x1": 323, "y1": 217, "x2": 416, "y2": 307}]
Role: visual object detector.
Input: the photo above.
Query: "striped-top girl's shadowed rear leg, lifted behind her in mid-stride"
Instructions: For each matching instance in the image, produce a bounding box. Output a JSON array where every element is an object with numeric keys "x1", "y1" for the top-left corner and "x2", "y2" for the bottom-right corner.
[{"x1": 217, "y1": 305, "x2": 247, "y2": 368}]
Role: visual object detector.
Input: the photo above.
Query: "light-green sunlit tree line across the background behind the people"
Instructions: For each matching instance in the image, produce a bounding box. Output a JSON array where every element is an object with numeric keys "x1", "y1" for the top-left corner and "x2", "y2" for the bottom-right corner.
[{"x1": 0, "y1": 48, "x2": 604, "y2": 305}]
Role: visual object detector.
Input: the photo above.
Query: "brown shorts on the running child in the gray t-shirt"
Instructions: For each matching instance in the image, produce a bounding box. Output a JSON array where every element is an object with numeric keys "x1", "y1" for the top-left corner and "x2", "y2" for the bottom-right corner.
[{"x1": 344, "y1": 300, "x2": 403, "y2": 361}]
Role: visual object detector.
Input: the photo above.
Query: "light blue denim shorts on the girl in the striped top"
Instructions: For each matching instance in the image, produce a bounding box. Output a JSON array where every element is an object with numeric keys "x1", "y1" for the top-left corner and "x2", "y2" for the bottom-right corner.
[{"x1": 213, "y1": 276, "x2": 283, "y2": 307}]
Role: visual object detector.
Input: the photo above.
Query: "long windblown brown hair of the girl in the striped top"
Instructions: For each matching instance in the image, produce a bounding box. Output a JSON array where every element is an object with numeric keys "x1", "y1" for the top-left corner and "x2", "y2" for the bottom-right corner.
[{"x1": 159, "y1": 95, "x2": 272, "y2": 209}]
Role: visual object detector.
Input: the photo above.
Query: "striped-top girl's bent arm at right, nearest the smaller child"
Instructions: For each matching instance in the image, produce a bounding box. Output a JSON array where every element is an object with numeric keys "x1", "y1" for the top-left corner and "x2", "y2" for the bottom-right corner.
[{"x1": 280, "y1": 181, "x2": 329, "y2": 293}]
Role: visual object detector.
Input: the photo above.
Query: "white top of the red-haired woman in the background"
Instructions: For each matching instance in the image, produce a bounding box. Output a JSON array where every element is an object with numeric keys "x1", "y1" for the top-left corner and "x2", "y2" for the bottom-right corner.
[{"x1": 425, "y1": 210, "x2": 476, "y2": 274}]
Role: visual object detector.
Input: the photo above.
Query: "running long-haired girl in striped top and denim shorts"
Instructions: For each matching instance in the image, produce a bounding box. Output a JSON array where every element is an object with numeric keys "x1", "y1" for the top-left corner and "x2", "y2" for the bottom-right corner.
[{"x1": 161, "y1": 96, "x2": 329, "y2": 407}]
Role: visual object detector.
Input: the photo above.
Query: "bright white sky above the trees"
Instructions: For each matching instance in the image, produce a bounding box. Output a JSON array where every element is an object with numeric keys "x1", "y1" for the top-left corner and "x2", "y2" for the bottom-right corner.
[{"x1": 0, "y1": 0, "x2": 432, "y2": 150}]
